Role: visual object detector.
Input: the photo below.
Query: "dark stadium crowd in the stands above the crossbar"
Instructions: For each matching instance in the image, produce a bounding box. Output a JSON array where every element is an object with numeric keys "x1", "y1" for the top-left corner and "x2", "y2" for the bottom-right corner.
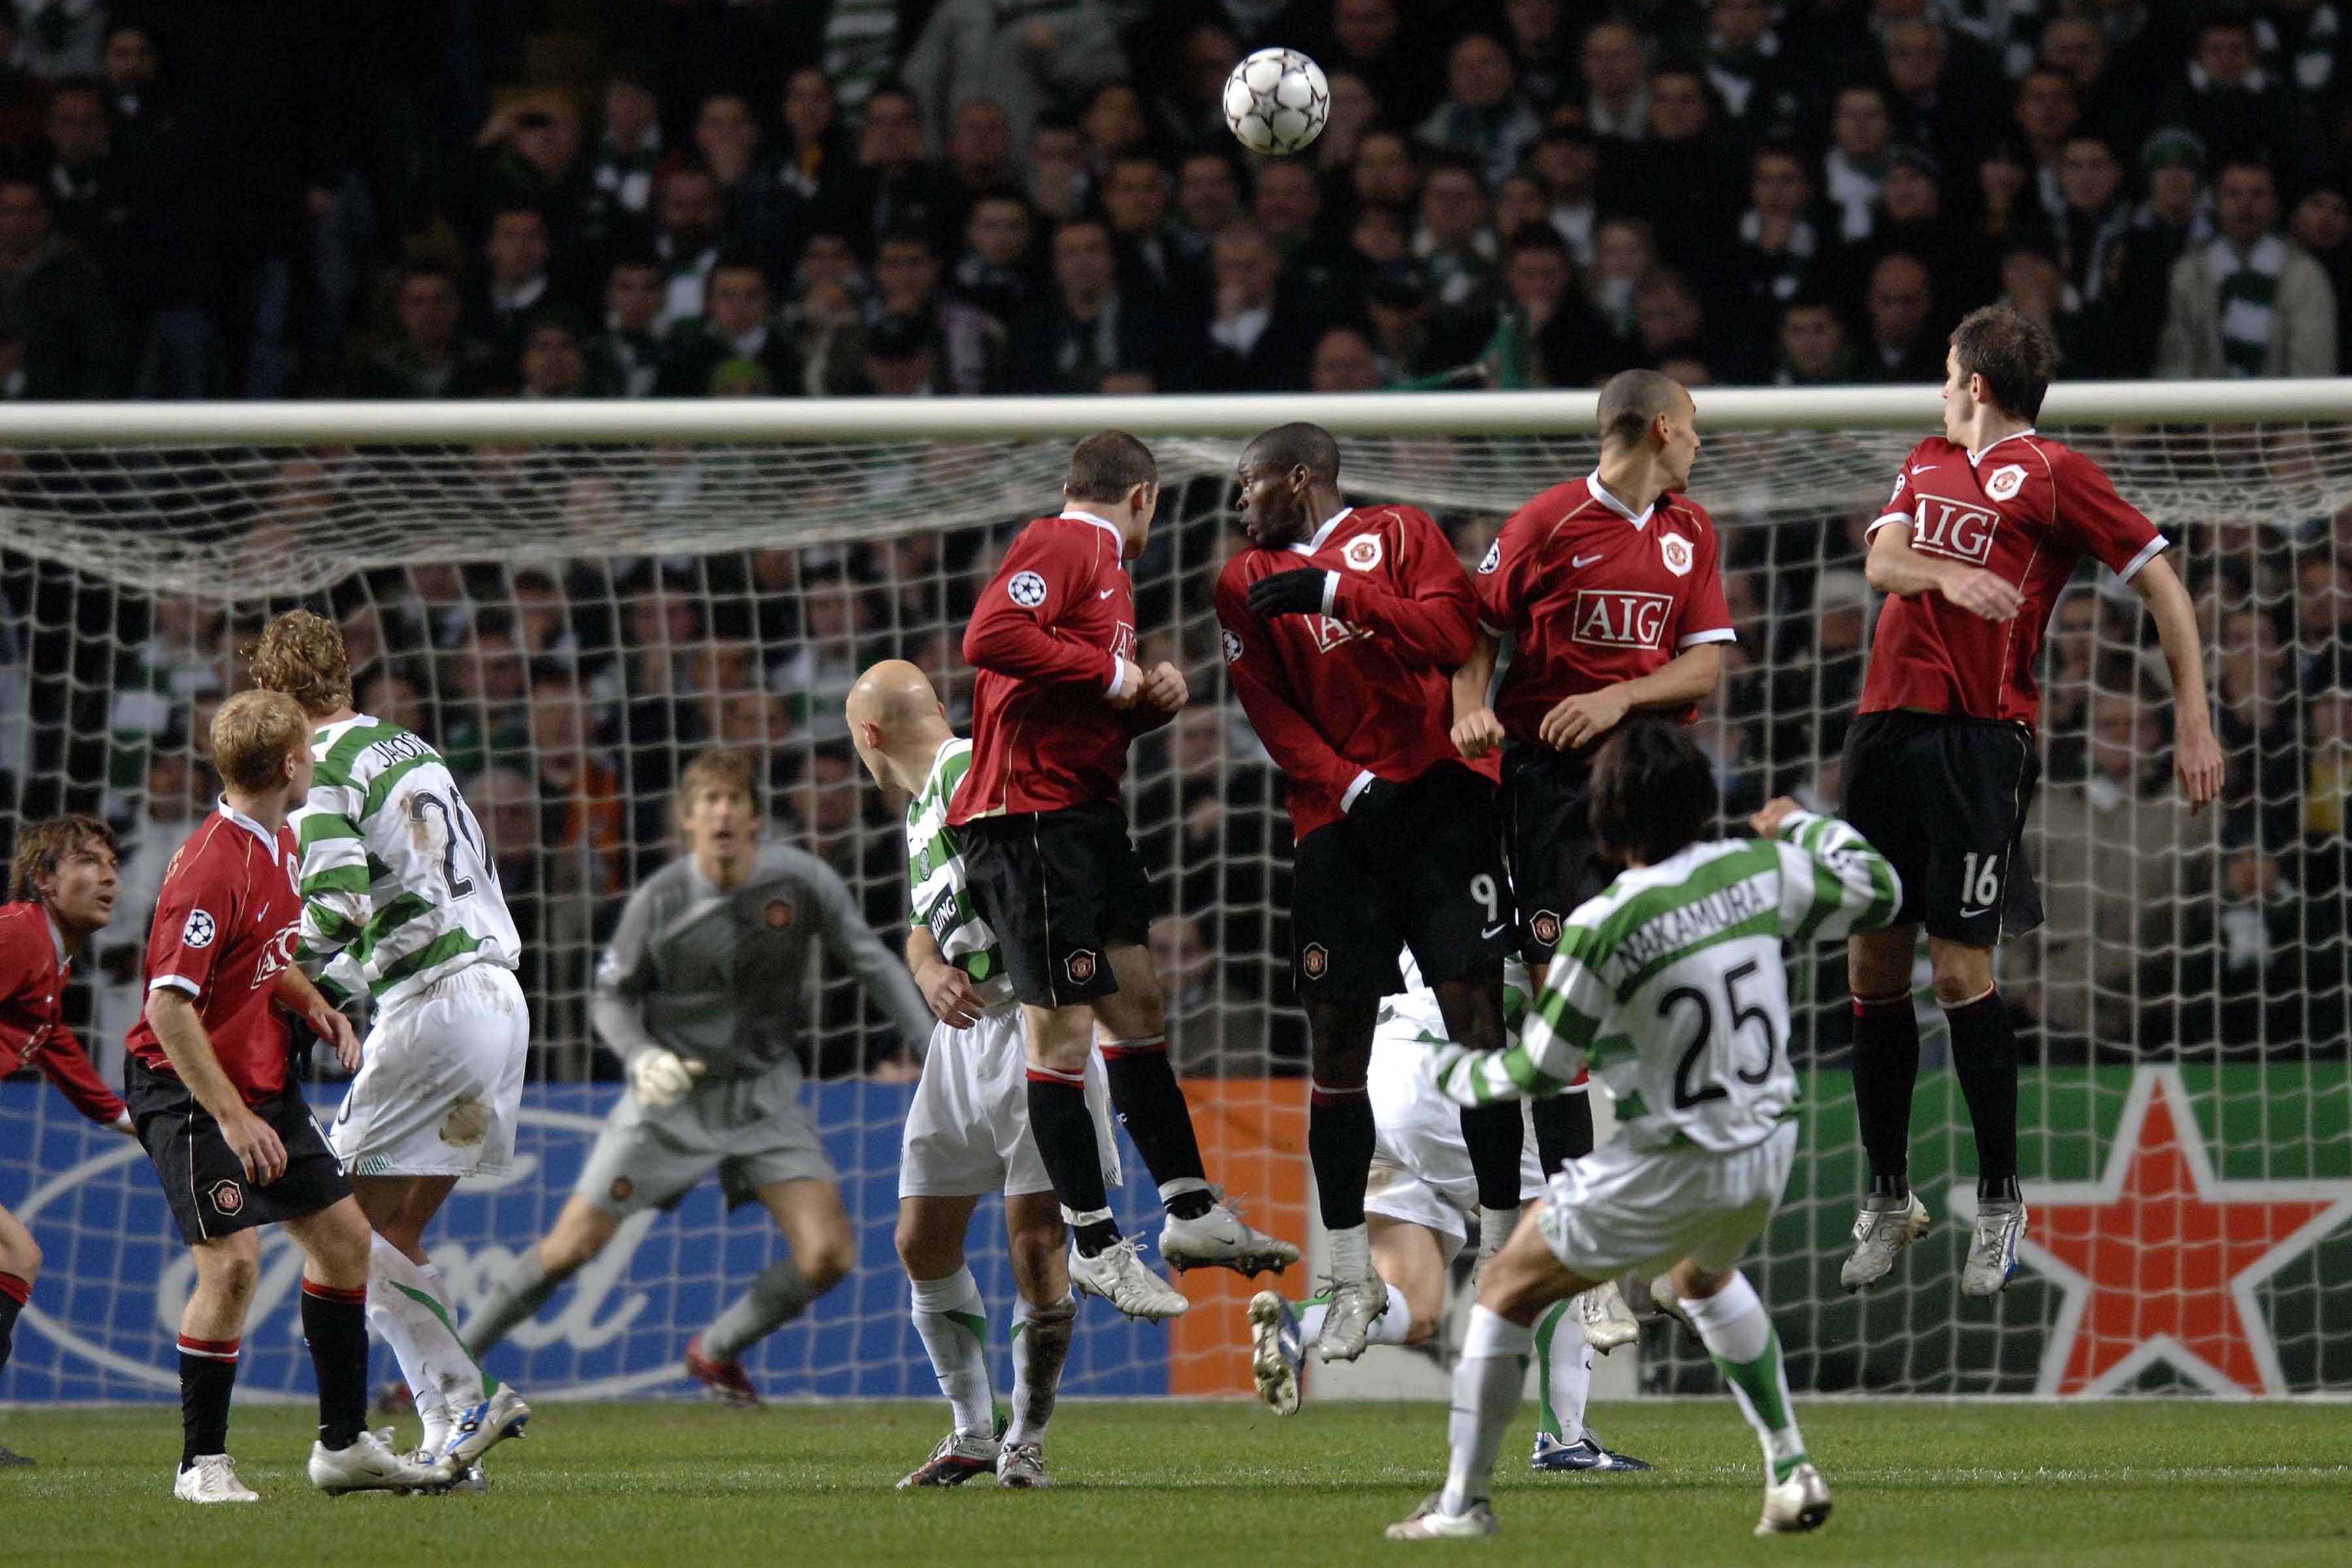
[{"x1": 0, "y1": 0, "x2": 2352, "y2": 397}]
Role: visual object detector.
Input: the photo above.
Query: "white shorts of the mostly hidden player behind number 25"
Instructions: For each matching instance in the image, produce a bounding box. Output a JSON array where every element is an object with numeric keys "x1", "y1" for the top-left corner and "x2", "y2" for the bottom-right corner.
[{"x1": 1364, "y1": 1022, "x2": 1543, "y2": 1253}]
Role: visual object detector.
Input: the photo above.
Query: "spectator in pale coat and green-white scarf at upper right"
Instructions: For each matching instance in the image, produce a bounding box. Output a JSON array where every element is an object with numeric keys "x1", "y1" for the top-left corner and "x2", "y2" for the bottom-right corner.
[{"x1": 2157, "y1": 157, "x2": 2336, "y2": 376}]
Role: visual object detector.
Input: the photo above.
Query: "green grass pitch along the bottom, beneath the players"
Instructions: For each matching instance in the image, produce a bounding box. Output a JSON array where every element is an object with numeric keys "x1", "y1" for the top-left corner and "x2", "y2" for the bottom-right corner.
[{"x1": 0, "y1": 1399, "x2": 2352, "y2": 1568}]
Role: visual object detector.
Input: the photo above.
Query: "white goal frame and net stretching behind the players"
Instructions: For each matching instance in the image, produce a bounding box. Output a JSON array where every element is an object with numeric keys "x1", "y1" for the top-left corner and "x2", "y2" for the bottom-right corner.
[{"x1": 0, "y1": 384, "x2": 2352, "y2": 1401}]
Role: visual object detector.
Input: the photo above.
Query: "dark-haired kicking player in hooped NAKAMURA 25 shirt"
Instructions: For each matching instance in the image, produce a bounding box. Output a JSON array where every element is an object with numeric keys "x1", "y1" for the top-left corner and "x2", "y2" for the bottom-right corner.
[{"x1": 1388, "y1": 719, "x2": 1901, "y2": 1540}]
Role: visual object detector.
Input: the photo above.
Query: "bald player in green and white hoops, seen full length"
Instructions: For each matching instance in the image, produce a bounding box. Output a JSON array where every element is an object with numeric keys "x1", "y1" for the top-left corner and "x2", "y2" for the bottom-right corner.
[{"x1": 849, "y1": 658, "x2": 1120, "y2": 1488}]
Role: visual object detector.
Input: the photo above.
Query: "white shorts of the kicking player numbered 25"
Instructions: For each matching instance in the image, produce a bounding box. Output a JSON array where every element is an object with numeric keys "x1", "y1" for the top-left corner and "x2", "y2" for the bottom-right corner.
[{"x1": 1538, "y1": 1121, "x2": 1797, "y2": 1279}]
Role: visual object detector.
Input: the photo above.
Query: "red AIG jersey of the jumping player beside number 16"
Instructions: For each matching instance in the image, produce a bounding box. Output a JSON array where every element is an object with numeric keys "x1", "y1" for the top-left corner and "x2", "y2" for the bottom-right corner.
[{"x1": 1475, "y1": 472, "x2": 1736, "y2": 743}]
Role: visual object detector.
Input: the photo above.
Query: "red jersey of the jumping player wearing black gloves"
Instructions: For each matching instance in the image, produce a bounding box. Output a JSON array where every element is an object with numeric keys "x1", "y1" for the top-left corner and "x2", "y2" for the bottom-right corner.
[{"x1": 1216, "y1": 506, "x2": 1477, "y2": 840}]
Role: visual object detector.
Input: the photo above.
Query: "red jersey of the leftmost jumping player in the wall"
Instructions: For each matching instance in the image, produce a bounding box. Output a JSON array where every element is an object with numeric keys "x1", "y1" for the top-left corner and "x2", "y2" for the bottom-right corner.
[{"x1": 948, "y1": 508, "x2": 1147, "y2": 828}]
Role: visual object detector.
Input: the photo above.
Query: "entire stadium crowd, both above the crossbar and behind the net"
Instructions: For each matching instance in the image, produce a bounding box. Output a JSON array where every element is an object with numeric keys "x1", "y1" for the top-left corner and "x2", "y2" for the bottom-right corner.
[{"x1": 0, "y1": 0, "x2": 2352, "y2": 1077}]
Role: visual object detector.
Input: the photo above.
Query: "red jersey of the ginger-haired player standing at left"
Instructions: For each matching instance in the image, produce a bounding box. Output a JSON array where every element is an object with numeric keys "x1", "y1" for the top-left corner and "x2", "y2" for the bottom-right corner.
[{"x1": 125, "y1": 799, "x2": 301, "y2": 1105}]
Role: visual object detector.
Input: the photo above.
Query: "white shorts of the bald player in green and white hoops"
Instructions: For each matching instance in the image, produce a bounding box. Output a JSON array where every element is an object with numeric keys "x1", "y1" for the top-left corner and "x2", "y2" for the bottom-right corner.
[{"x1": 898, "y1": 1004, "x2": 1120, "y2": 1199}]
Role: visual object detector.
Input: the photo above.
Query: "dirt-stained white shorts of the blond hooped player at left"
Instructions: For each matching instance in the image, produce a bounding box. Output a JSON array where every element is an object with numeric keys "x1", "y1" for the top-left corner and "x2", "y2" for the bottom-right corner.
[{"x1": 327, "y1": 964, "x2": 532, "y2": 1175}]
